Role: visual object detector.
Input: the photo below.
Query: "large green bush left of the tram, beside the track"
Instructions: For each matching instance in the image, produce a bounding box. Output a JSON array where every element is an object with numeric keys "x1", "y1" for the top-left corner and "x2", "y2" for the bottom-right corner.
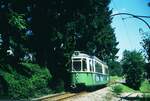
[{"x1": 0, "y1": 63, "x2": 51, "y2": 99}]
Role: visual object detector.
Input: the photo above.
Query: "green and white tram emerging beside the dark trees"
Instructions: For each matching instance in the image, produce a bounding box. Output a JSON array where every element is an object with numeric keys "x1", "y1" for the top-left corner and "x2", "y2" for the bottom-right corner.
[{"x1": 71, "y1": 51, "x2": 109, "y2": 88}]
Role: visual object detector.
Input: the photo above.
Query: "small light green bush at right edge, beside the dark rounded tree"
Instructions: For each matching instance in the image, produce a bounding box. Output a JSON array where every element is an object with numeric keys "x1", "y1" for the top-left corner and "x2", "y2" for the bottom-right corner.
[{"x1": 140, "y1": 80, "x2": 150, "y2": 93}]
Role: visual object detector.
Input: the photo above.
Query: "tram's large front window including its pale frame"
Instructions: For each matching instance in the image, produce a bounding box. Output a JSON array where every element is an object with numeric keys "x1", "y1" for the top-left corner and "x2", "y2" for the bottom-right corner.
[{"x1": 72, "y1": 59, "x2": 81, "y2": 71}]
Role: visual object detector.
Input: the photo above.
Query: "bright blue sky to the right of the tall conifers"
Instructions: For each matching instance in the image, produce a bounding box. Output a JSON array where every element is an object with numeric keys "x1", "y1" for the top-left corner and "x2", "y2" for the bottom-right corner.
[{"x1": 109, "y1": 0, "x2": 150, "y2": 60}]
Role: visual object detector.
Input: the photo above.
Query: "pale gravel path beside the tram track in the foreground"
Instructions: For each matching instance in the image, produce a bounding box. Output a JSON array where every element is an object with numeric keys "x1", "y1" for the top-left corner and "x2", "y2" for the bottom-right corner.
[{"x1": 32, "y1": 87, "x2": 150, "y2": 101}]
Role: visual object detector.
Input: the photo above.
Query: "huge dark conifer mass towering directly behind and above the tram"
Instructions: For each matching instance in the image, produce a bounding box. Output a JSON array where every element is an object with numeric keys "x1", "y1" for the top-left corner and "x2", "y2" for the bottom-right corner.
[{"x1": 31, "y1": 0, "x2": 118, "y2": 88}]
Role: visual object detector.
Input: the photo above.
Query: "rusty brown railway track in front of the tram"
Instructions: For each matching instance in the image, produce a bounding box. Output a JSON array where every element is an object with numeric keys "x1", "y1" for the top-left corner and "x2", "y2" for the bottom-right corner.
[{"x1": 33, "y1": 92, "x2": 87, "y2": 101}]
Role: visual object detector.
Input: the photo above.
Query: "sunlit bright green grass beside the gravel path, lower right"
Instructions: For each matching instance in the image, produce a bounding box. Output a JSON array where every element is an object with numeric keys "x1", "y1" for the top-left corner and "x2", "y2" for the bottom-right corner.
[{"x1": 108, "y1": 76, "x2": 150, "y2": 101}]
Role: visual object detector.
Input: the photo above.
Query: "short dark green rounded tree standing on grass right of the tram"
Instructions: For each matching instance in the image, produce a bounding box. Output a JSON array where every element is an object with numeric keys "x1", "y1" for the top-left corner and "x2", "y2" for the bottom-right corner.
[{"x1": 121, "y1": 50, "x2": 145, "y2": 89}]
